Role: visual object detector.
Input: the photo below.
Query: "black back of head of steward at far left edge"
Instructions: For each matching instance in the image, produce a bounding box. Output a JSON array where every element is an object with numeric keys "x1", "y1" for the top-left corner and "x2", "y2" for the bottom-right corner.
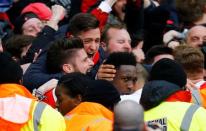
[{"x1": 0, "y1": 52, "x2": 23, "y2": 84}]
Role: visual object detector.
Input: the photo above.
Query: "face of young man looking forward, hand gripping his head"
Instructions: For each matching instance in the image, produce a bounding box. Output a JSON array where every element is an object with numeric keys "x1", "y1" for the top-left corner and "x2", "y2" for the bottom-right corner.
[{"x1": 112, "y1": 65, "x2": 137, "y2": 94}]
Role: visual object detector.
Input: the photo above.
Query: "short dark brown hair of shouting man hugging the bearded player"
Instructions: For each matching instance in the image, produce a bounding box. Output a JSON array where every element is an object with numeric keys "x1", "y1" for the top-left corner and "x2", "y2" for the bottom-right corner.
[{"x1": 68, "y1": 13, "x2": 99, "y2": 36}]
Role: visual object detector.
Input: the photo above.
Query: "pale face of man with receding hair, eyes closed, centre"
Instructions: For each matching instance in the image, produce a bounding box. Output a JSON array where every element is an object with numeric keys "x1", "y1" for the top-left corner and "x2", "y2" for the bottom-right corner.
[{"x1": 106, "y1": 28, "x2": 132, "y2": 54}]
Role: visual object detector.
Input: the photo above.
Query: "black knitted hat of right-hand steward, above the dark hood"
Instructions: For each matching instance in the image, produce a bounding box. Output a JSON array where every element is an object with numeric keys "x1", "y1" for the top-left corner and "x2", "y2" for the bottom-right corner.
[{"x1": 150, "y1": 58, "x2": 187, "y2": 87}]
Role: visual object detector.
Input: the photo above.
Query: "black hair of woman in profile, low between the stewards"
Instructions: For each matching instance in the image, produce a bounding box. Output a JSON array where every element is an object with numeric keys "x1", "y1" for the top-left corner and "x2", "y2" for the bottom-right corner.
[{"x1": 57, "y1": 72, "x2": 89, "y2": 98}]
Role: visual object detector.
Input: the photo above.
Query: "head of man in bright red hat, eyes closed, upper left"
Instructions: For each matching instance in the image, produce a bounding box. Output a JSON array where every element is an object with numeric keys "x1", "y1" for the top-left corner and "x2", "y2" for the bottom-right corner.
[{"x1": 14, "y1": 2, "x2": 54, "y2": 37}]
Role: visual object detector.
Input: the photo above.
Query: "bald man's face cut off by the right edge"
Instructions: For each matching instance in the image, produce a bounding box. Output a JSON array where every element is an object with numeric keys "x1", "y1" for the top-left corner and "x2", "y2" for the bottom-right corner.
[{"x1": 186, "y1": 26, "x2": 206, "y2": 48}]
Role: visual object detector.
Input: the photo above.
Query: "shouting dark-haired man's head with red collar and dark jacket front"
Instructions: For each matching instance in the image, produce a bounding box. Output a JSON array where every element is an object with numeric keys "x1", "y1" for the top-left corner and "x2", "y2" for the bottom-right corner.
[{"x1": 68, "y1": 13, "x2": 105, "y2": 78}]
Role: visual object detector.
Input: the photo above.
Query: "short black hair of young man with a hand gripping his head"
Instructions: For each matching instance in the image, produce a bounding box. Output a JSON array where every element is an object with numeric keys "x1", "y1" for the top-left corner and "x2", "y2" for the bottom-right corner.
[{"x1": 104, "y1": 52, "x2": 137, "y2": 69}]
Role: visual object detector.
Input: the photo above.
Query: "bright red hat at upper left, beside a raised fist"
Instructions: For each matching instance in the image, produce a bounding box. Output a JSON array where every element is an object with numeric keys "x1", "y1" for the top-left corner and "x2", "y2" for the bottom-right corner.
[{"x1": 21, "y1": 2, "x2": 52, "y2": 20}]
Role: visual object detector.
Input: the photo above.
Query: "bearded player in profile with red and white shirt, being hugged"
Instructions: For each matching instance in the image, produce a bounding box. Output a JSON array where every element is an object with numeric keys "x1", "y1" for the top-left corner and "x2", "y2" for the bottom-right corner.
[{"x1": 33, "y1": 38, "x2": 94, "y2": 108}]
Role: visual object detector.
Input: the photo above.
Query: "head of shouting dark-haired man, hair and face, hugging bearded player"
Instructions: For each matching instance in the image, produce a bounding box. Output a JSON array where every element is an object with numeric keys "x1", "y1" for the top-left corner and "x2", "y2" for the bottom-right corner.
[{"x1": 69, "y1": 13, "x2": 100, "y2": 58}]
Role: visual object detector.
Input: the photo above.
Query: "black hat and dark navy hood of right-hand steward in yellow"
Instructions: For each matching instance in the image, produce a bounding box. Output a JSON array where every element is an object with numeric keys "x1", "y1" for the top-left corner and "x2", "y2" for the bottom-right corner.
[{"x1": 140, "y1": 58, "x2": 187, "y2": 110}]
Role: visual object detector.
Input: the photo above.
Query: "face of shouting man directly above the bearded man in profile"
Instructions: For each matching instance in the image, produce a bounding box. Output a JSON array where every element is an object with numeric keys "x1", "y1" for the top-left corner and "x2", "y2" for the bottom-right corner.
[{"x1": 79, "y1": 28, "x2": 100, "y2": 57}]
